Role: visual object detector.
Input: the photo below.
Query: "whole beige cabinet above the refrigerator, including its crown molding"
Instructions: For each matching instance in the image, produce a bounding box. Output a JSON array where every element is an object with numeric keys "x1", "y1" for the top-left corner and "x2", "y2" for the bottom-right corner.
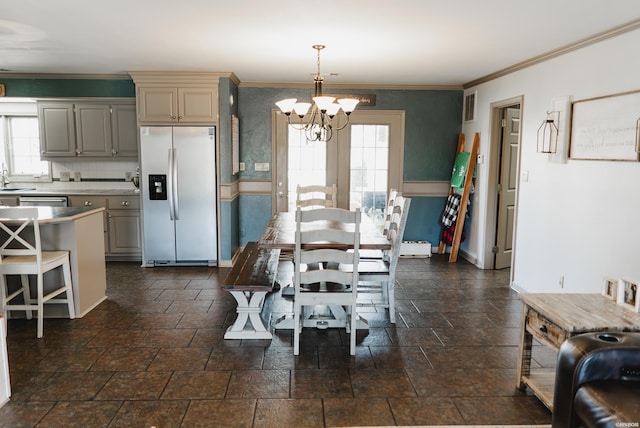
[{"x1": 129, "y1": 71, "x2": 221, "y2": 125}]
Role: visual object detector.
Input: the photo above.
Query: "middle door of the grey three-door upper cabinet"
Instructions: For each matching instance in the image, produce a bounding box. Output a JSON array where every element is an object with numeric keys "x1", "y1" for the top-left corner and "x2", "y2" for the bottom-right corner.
[{"x1": 75, "y1": 103, "x2": 111, "y2": 157}]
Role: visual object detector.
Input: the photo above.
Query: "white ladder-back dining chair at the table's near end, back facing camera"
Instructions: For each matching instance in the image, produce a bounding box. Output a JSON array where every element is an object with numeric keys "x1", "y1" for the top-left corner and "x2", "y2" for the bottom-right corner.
[{"x1": 293, "y1": 208, "x2": 361, "y2": 355}]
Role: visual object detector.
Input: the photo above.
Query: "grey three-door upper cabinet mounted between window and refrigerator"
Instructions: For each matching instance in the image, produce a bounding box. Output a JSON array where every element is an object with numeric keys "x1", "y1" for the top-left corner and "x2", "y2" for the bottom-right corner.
[{"x1": 38, "y1": 101, "x2": 138, "y2": 159}]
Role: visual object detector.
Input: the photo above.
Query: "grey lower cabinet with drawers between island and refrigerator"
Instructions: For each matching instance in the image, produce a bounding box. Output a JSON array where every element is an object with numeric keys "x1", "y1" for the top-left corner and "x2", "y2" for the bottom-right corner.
[{"x1": 69, "y1": 196, "x2": 142, "y2": 260}]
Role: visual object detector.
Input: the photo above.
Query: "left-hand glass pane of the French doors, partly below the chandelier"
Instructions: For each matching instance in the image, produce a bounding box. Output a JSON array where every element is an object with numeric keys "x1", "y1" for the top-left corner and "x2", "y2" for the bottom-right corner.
[{"x1": 288, "y1": 125, "x2": 327, "y2": 211}]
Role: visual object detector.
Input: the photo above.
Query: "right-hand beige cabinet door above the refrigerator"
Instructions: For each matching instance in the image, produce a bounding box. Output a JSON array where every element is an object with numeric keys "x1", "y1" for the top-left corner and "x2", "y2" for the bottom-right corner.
[{"x1": 178, "y1": 87, "x2": 218, "y2": 125}]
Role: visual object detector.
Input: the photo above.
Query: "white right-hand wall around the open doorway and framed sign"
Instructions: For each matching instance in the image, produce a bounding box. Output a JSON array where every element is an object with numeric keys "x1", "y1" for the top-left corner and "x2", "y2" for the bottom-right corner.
[{"x1": 463, "y1": 30, "x2": 640, "y2": 293}]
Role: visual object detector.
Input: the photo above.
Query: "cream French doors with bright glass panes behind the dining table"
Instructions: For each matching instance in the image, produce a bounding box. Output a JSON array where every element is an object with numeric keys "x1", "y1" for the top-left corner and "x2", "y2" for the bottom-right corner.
[{"x1": 273, "y1": 111, "x2": 404, "y2": 216}]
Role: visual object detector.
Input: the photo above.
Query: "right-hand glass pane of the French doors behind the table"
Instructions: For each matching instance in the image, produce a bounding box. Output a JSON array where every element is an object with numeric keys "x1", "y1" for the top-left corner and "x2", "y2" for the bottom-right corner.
[{"x1": 349, "y1": 125, "x2": 389, "y2": 221}]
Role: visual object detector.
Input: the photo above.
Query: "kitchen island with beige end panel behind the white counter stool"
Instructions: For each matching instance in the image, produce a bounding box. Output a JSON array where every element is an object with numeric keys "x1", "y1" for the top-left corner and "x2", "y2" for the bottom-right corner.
[{"x1": 0, "y1": 207, "x2": 107, "y2": 318}]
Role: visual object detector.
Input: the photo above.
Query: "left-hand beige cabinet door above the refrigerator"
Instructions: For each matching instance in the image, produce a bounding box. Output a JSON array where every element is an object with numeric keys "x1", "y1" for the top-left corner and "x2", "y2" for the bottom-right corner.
[{"x1": 138, "y1": 86, "x2": 178, "y2": 124}]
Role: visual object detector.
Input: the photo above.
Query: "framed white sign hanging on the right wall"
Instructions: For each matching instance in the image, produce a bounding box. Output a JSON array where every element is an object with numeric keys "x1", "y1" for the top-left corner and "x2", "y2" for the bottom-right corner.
[{"x1": 569, "y1": 91, "x2": 640, "y2": 162}]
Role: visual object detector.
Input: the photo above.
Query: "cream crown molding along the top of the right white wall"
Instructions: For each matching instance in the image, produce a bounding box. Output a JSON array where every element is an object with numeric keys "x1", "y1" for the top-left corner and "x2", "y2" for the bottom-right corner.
[{"x1": 462, "y1": 18, "x2": 640, "y2": 89}]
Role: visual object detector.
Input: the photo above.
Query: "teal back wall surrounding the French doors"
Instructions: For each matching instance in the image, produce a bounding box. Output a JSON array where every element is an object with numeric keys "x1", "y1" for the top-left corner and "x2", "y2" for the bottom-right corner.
[{"x1": 239, "y1": 86, "x2": 463, "y2": 245}]
